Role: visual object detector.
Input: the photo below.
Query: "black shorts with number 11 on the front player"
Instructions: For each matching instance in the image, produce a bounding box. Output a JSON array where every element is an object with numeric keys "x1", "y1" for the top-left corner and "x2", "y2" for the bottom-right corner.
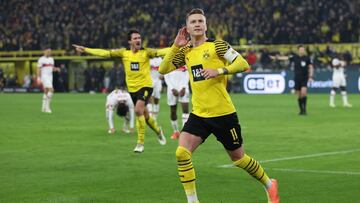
[{"x1": 182, "y1": 113, "x2": 243, "y2": 151}]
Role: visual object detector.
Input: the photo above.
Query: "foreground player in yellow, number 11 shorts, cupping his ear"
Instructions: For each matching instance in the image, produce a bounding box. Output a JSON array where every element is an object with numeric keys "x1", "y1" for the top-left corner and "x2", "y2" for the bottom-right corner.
[{"x1": 159, "y1": 9, "x2": 279, "y2": 203}]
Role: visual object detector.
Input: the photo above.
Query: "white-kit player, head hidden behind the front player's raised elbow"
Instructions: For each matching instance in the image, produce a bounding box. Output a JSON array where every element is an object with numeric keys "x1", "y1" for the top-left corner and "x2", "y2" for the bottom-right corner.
[{"x1": 164, "y1": 66, "x2": 190, "y2": 139}]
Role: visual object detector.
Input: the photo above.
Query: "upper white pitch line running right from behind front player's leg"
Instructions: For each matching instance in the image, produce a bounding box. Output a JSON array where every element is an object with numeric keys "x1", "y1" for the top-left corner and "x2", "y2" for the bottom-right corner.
[{"x1": 219, "y1": 149, "x2": 360, "y2": 168}]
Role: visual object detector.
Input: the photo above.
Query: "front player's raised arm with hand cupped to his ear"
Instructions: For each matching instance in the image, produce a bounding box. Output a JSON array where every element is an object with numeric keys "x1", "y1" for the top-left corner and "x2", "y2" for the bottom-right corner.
[{"x1": 159, "y1": 27, "x2": 189, "y2": 75}]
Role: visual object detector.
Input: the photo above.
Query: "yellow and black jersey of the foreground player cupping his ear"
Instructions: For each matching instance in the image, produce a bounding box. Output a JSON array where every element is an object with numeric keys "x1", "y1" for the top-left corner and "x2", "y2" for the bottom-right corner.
[{"x1": 159, "y1": 40, "x2": 249, "y2": 118}]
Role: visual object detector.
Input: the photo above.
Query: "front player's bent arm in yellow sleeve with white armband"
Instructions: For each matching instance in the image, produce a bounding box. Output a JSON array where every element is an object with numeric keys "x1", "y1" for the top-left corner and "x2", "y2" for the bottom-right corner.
[{"x1": 214, "y1": 40, "x2": 250, "y2": 74}]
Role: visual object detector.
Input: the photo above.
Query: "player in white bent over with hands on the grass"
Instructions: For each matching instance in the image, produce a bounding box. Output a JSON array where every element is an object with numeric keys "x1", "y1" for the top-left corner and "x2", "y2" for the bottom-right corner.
[{"x1": 105, "y1": 89, "x2": 135, "y2": 134}]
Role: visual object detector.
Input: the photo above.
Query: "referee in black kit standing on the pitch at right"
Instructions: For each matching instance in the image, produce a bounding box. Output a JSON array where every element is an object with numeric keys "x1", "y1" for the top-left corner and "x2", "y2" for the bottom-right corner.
[{"x1": 270, "y1": 45, "x2": 314, "y2": 115}]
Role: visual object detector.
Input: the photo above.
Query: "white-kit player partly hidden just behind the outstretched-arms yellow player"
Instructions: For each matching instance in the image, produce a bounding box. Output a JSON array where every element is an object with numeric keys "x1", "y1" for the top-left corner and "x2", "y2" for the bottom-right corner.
[{"x1": 147, "y1": 57, "x2": 163, "y2": 120}]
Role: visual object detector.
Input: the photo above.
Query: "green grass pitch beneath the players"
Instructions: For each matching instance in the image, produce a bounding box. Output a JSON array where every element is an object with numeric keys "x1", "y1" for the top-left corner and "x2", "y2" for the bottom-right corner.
[{"x1": 0, "y1": 93, "x2": 360, "y2": 203}]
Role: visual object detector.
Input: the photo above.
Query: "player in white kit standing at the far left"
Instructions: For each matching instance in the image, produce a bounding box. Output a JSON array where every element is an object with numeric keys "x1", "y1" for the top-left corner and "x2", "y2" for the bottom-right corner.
[{"x1": 36, "y1": 48, "x2": 60, "y2": 113}]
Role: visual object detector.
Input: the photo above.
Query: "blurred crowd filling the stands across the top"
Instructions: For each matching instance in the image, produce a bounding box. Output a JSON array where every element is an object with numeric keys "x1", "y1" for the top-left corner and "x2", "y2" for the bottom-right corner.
[{"x1": 0, "y1": 0, "x2": 360, "y2": 51}]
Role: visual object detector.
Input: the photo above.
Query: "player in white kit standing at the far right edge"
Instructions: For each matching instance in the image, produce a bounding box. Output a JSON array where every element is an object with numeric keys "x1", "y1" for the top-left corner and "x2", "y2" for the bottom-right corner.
[{"x1": 330, "y1": 58, "x2": 352, "y2": 107}]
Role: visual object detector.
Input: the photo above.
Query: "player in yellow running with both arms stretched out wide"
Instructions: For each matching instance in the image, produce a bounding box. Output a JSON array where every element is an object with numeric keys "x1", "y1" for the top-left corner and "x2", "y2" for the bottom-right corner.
[{"x1": 73, "y1": 30, "x2": 167, "y2": 153}]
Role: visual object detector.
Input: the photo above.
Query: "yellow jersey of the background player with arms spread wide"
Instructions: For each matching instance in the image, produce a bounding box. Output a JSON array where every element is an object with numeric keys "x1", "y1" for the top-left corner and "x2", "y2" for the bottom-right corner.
[{"x1": 85, "y1": 48, "x2": 169, "y2": 92}]
